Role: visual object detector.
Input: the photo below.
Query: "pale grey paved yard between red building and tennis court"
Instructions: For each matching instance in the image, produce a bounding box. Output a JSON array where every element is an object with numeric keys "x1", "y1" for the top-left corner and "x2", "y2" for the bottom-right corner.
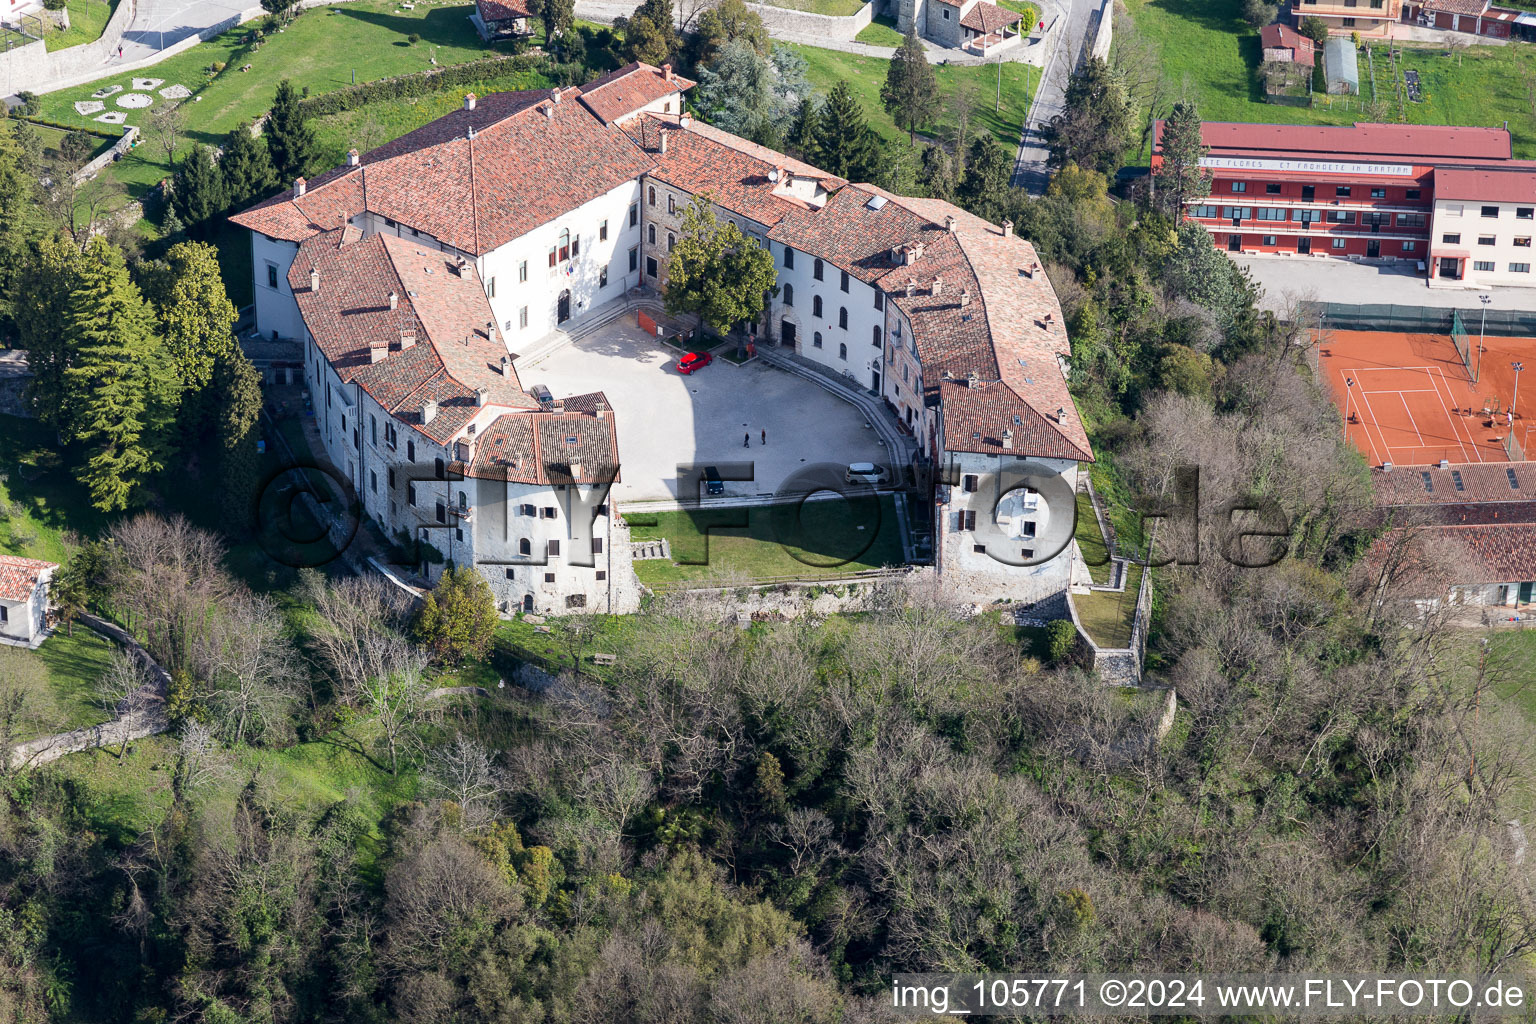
[{"x1": 1232, "y1": 256, "x2": 1536, "y2": 313}]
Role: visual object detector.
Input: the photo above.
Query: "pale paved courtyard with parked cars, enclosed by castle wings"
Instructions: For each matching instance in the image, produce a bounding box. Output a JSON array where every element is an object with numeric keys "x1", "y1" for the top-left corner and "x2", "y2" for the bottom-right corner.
[{"x1": 516, "y1": 315, "x2": 891, "y2": 502}]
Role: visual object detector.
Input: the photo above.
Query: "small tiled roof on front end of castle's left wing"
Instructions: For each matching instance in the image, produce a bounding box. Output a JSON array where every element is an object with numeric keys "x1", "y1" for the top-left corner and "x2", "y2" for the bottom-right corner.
[{"x1": 465, "y1": 391, "x2": 619, "y2": 484}]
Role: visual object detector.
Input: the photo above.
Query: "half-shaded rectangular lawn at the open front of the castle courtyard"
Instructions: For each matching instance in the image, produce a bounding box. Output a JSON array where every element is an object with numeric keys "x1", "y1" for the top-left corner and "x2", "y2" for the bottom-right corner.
[{"x1": 625, "y1": 497, "x2": 902, "y2": 585}]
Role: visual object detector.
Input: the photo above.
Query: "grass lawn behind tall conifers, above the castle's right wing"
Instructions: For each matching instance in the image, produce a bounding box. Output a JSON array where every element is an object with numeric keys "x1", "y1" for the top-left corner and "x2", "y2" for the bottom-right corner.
[{"x1": 783, "y1": 43, "x2": 1040, "y2": 152}]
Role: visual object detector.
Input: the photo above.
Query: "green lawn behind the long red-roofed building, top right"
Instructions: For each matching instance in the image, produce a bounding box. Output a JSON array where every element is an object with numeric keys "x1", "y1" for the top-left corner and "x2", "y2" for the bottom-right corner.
[{"x1": 1126, "y1": 0, "x2": 1536, "y2": 160}]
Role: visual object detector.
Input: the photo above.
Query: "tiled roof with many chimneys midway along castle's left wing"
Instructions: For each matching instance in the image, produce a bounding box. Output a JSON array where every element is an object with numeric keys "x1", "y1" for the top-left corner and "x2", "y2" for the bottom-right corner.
[{"x1": 289, "y1": 230, "x2": 538, "y2": 444}]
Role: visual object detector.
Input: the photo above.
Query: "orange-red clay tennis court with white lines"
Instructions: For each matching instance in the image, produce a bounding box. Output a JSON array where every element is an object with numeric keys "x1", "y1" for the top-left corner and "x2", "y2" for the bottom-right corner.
[{"x1": 1318, "y1": 330, "x2": 1536, "y2": 465}]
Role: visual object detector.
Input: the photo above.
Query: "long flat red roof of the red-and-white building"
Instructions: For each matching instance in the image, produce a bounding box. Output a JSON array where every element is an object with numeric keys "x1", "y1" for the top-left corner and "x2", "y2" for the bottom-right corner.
[{"x1": 1155, "y1": 121, "x2": 1510, "y2": 164}]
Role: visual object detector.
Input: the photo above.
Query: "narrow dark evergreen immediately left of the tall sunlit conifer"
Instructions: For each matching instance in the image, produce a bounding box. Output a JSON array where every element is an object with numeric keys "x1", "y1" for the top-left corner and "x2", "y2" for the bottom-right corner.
[{"x1": 11, "y1": 235, "x2": 80, "y2": 428}]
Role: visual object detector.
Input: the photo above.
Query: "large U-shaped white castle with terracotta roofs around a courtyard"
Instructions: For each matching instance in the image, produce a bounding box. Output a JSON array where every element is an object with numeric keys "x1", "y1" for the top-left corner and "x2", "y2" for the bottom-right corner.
[{"x1": 232, "y1": 63, "x2": 1092, "y2": 611}]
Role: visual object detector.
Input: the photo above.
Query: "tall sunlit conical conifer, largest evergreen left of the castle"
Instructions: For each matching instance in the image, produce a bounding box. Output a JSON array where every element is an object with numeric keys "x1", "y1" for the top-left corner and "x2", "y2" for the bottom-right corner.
[{"x1": 63, "y1": 238, "x2": 180, "y2": 511}]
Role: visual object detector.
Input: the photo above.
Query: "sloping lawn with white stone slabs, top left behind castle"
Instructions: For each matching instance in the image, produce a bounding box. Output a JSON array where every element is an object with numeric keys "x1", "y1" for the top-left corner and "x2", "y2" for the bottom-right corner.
[{"x1": 38, "y1": 0, "x2": 492, "y2": 200}]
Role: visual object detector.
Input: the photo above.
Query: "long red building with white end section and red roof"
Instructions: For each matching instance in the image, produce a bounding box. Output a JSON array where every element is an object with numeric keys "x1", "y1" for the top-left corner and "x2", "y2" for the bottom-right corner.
[{"x1": 1152, "y1": 123, "x2": 1536, "y2": 286}]
